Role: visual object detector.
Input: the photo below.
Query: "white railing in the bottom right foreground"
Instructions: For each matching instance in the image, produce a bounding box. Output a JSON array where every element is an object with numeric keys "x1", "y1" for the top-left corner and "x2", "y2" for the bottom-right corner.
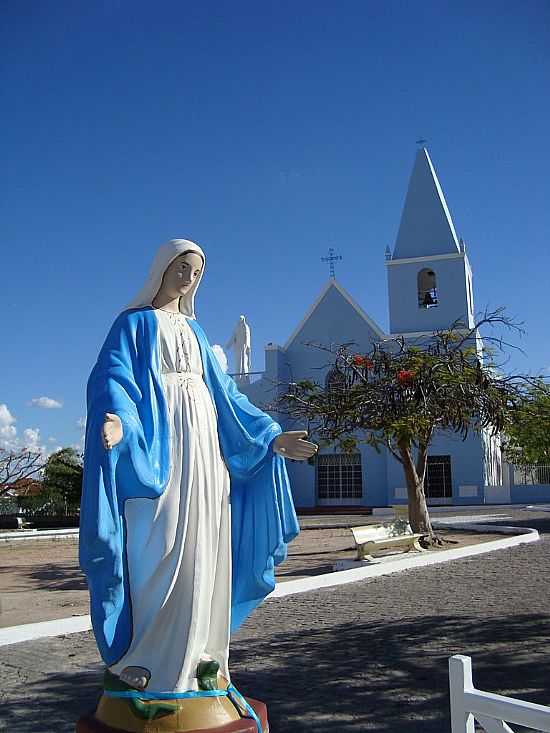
[{"x1": 449, "y1": 654, "x2": 550, "y2": 733}]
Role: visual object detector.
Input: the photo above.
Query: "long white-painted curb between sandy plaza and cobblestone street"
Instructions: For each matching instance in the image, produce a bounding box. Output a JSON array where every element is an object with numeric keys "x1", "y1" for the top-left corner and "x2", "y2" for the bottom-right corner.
[{"x1": 0, "y1": 520, "x2": 540, "y2": 647}]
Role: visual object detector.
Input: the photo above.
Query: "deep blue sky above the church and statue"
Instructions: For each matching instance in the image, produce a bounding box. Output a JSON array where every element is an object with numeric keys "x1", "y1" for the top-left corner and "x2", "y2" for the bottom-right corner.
[{"x1": 0, "y1": 0, "x2": 550, "y2": 454}]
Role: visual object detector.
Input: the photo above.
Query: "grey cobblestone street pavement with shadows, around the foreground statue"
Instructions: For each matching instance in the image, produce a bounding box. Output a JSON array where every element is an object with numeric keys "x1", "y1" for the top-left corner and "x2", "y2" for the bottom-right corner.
[{"x1": 0, "y1": 509, "x2": 550, "y2": 733}]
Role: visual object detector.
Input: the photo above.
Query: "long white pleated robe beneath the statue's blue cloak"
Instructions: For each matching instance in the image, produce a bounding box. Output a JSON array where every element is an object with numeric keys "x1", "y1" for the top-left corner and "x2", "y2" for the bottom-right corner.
[{"x1": 111, "y1": 310, "x2": 231, "y2": 692}]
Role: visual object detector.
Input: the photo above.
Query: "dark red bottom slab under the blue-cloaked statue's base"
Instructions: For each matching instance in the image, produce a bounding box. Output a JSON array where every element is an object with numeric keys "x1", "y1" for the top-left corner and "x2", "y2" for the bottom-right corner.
[{"x1": 76, "y1": 697, "x2": 269, "y2": 733}]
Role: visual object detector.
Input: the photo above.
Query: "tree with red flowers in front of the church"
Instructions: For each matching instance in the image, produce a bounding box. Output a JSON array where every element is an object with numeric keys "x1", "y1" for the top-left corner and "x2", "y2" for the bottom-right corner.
[{"x1": 279, "y1": 309, "x2": 536, "y2": 543}]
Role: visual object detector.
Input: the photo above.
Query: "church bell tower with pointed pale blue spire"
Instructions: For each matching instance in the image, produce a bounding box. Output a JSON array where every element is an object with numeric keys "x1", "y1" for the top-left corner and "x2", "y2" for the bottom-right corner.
[{"x1": 386, "y1": 148, "x2": 474, "y2": 335}]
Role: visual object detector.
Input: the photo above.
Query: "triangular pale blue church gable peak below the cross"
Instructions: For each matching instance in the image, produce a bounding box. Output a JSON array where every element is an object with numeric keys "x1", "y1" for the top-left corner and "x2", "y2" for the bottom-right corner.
[{"x1": 284, "y1": 280, "x2": 385, "y2": 351}]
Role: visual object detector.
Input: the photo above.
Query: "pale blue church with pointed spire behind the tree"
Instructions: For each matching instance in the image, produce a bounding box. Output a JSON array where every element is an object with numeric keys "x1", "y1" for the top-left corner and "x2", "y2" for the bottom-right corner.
[{"x1": 237, "y1": 148, "x2": 550, "y2": 508}]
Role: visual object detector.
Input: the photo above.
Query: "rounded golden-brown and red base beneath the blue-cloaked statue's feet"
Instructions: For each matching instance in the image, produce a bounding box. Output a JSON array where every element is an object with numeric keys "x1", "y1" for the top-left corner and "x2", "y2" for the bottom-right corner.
[{"x1": 76, "y1": 673, "x2": 269, "y2": 733}]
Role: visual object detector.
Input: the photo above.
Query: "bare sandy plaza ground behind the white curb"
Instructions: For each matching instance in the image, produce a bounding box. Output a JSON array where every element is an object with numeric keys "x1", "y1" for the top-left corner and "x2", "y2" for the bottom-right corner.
[{"x1": 0, "y1": 527, "x2": 498, "y2": 627}]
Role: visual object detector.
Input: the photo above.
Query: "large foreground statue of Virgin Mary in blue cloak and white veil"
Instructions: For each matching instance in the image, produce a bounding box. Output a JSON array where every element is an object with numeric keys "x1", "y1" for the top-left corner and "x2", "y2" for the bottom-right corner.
[{"x1": 80, "y1": 239, "x2": 317, "y2": 716}]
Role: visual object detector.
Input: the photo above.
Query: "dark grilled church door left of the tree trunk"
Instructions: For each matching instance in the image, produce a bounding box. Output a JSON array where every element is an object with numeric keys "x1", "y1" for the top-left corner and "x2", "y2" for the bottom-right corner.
[{"x1": 316, "y1": 453, "x2": 363, "y2": 506}]
